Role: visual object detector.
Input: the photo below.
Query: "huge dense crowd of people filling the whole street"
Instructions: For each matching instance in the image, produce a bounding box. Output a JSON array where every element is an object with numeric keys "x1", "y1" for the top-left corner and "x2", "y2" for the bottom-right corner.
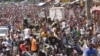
[{"x1": 0, "y1": 3, "x2": 100, "y2": 56}]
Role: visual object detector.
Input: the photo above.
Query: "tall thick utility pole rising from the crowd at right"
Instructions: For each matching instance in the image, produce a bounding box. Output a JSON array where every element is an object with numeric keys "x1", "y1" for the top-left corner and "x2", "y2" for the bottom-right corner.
[{"x1": 85, "y1": 0, "x2": 93, "y2": 37}]
